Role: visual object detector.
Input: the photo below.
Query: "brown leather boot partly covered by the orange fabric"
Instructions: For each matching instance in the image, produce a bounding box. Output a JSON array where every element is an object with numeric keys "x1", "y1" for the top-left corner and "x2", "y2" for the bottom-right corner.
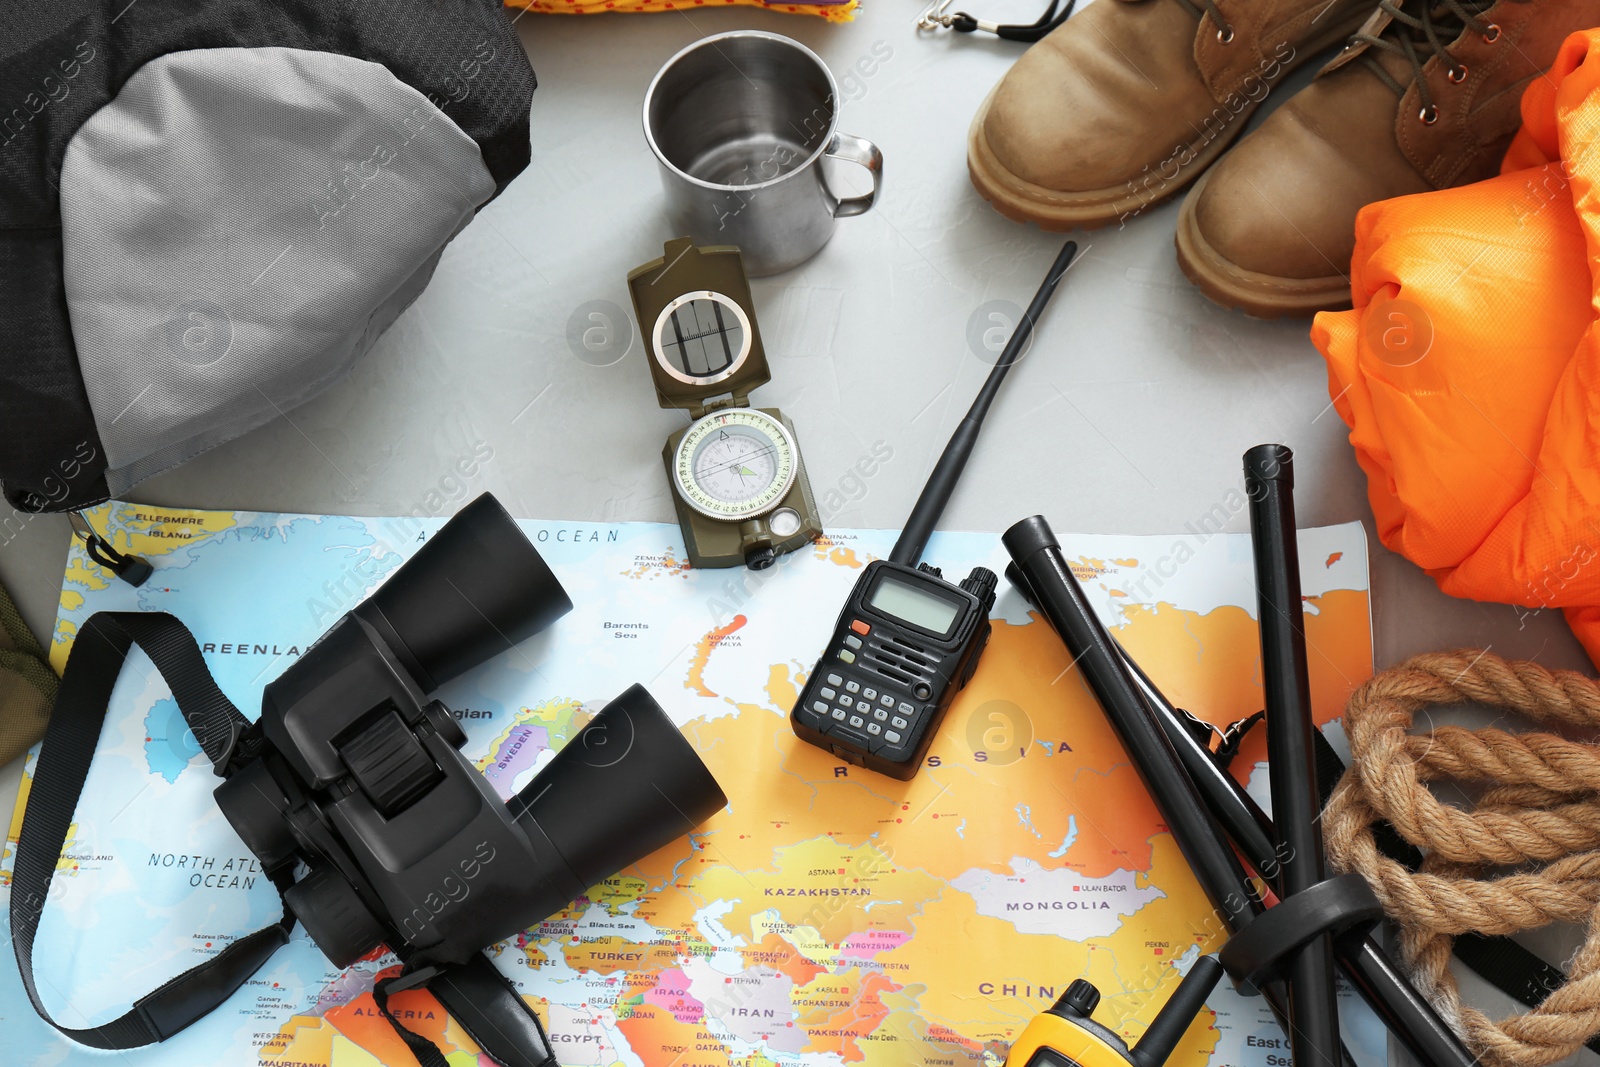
[{"x1": 1178, "y1": 0, "x2": 1600, "y2": 318}]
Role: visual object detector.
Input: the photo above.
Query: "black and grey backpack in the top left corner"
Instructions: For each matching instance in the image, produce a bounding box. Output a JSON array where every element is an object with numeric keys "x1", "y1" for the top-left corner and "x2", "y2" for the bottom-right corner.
[{"x1": 0, "y1": 0, "x2": 534, "y2": 512}]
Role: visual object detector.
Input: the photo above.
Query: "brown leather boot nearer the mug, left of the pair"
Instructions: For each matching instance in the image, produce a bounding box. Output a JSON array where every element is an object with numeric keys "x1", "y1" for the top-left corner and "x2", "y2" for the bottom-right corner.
[{"x1": 966, "y1": 0, "x2": 1373, "y2": 230}]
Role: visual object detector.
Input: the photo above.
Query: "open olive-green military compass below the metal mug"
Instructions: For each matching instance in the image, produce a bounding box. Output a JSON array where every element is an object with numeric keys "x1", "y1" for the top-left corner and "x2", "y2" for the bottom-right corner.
[{"x1": 627, "y1": 237, "x2": 822, "y2": 569}]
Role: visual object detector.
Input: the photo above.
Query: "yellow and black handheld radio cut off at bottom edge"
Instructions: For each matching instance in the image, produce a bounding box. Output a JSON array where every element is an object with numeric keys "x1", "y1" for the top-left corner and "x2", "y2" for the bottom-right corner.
[{"x1": 1005, "y1": 957, "x2": 1222, "y2": 1067}]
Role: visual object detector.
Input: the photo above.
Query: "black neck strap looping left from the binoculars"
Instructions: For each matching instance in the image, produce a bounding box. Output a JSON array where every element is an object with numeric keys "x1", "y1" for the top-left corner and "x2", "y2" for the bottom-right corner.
[{"x1": 11, "y1": 611, "x2": 294, "y2": 1049}]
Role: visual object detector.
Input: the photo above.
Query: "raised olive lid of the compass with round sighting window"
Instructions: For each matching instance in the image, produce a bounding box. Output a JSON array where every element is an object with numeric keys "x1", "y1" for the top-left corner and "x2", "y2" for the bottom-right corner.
[{"x1": 627, "y1": 237, "x2": 771, "y2": 414}]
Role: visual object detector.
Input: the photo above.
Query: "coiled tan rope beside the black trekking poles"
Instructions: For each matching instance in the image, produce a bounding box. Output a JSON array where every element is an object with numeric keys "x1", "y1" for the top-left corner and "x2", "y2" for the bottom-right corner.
[{"x1": 1323, "y1": 651, "x2": 1600, "y2": 1067}]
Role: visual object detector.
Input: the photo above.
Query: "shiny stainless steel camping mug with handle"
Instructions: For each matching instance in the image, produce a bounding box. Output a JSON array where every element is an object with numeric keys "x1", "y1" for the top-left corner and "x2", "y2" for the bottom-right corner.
[{"x1": 645, "y1": 30, "x2": 883, "y2": 275}]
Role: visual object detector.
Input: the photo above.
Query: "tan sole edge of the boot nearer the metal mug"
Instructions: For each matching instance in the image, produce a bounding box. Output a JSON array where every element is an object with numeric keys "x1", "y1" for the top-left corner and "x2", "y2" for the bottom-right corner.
[{"x1": 966, "y1": 10, "x2": 1368, "y2": 232}]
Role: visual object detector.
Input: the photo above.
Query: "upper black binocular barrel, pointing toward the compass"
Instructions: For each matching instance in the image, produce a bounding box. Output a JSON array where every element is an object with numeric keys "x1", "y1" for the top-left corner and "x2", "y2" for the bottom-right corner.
[{"x1": 355, "y1": 493, "x2": 573, "y2": 693}]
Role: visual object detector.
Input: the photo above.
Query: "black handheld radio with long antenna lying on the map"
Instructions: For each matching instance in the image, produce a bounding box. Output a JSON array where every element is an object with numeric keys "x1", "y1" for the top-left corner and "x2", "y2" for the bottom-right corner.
[{"x1": 789, "y1": 242, "x2": 1078, "y2": 781}]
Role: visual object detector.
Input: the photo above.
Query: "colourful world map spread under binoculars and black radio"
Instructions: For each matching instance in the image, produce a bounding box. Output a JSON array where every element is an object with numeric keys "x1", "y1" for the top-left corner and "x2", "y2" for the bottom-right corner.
[{"x1": 0, "y1": 498, "x2": 1386, "y2": 1067}]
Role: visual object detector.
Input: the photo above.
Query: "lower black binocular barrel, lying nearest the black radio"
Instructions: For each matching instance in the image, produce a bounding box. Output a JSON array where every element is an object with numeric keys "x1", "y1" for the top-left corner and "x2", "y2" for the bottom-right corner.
[{"x1": 509, "y1": 685, "x2": 728, "y2": 886}]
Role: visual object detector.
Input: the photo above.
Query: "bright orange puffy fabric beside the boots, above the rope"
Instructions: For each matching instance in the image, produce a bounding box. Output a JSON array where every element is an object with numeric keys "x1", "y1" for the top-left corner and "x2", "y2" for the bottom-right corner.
[{"x1": 1312, "y1": 30, "x2": 1600, "y2": 664}]
